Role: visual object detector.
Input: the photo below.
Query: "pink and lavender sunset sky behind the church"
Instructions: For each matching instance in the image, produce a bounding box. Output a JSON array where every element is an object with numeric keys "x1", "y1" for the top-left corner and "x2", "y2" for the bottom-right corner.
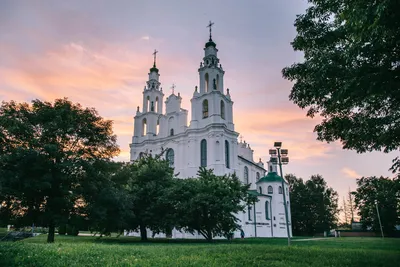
[{"x1": 0, "y1": 0, "x2": 398, "y2": 214}]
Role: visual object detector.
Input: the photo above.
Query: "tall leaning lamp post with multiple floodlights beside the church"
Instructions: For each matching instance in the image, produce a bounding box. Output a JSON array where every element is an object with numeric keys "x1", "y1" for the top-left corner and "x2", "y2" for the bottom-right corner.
[{"x1": 269, "y1": 142, "x2": 290, "y2": 246}]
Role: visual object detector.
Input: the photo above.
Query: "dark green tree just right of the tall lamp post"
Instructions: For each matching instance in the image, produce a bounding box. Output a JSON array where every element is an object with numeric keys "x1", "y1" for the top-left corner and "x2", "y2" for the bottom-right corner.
[{"x1": 285, "y1": 174, "x2": 339, "y2": 235}]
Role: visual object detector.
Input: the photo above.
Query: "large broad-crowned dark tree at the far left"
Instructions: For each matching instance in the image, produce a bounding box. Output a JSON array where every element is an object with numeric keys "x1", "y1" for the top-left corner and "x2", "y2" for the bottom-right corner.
[{"x1": 0, "y1": 99, "x2": 119, "y2": 242}]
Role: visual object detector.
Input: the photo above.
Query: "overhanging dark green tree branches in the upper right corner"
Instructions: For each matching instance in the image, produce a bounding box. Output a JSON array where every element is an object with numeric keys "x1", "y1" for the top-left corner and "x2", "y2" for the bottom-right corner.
[{"x1": 282, "y1": 0, "x2": 400, "y2": 172}]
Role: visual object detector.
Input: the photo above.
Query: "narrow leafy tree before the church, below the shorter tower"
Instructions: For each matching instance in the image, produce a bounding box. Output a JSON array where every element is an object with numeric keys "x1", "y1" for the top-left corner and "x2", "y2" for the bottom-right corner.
[{"x1": 126, "y1": 154, "x2": 174, "y2": 241}]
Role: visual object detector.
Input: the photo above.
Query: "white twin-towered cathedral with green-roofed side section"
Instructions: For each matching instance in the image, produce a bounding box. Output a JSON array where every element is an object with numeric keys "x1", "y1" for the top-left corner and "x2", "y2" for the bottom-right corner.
[{"x1": 130, "y1": 24, "x2": 291, "y2": 238}]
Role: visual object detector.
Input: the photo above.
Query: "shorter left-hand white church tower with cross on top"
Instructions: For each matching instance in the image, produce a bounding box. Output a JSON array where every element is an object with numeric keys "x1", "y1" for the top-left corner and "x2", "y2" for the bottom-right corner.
[{"x1": 134, "y1": 50, "x2": 164, "y2": 142}]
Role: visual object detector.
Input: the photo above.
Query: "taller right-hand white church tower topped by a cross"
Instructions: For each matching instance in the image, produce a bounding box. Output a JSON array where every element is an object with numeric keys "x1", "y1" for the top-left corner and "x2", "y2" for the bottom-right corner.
[{"x1": 190, "y1": 22, "x2": 234, "y2": 131}]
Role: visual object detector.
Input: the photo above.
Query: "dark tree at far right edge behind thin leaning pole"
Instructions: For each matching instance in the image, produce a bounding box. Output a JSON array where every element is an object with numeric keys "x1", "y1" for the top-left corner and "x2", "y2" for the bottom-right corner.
[{"x1": 354, "y1": 176, "x2": 400, "y2": 235}]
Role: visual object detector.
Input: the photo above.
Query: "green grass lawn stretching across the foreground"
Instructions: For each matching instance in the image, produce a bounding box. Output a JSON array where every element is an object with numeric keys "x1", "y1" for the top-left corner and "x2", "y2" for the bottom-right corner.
[{"x1": 0, "y1": 235, "x2": 400, "y2": 267}]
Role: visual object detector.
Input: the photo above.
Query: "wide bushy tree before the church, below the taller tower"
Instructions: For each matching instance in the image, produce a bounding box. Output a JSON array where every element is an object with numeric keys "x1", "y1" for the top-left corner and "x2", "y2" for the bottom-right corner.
[{"x1": 173, "y1": 170, "x2": 256, "y2": 241}]
